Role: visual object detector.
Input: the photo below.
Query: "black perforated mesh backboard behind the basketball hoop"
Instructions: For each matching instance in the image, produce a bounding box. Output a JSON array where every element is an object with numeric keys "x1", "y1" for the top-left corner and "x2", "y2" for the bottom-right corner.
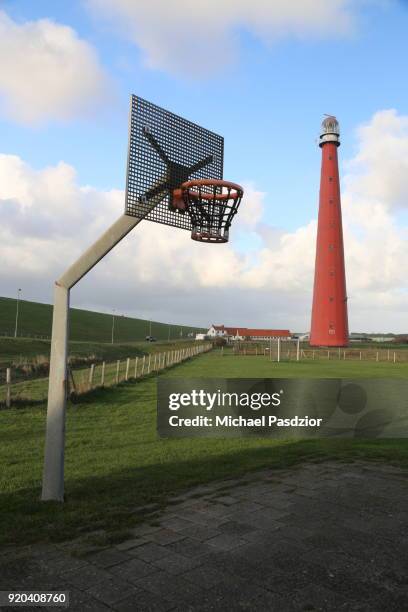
[{"x1": 125, "y1": 96, "x2": 224, "y2": 230}]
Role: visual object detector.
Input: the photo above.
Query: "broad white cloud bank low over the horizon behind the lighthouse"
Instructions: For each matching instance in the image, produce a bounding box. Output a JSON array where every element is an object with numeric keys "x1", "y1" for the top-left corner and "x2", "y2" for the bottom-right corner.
[{"x1": 0, "y1": 111, "x2": 408, "y2": 332}]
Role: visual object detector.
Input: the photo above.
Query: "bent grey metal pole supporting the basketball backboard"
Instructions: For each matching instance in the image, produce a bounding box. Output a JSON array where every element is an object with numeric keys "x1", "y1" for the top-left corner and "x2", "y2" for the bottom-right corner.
[{"x1": 41, "y1": 215, "x2": 141, "y2": 501}]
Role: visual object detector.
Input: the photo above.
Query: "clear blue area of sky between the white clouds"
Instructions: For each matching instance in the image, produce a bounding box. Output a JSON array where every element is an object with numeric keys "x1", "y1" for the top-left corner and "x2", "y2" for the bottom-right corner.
[{"x1": 0, "y1": 0, "x2": 408, "y2": 229}]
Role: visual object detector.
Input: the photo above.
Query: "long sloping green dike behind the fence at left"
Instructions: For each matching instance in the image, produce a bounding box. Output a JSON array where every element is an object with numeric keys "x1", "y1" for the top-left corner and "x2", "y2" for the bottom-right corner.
[{"x1": 0, "y1": 297, "x2": 203, "y2": 343}]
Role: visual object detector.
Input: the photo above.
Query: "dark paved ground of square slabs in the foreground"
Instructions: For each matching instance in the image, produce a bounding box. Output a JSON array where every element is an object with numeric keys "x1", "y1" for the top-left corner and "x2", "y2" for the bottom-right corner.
[{"x1": 0, "y1": 462, "x2": 408, "y2": 612}]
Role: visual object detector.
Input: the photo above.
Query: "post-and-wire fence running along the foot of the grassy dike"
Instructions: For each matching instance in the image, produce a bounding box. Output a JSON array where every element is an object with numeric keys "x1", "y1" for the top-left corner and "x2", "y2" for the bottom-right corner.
[{"x1": 0, "y1": 343, "x2": 213, "y2": 408}]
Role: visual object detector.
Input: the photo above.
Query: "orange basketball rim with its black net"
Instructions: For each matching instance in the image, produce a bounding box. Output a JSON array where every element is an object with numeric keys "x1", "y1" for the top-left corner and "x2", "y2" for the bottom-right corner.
[{"x1": 173, "y1": 179, "x2": 244, "y2": 244}]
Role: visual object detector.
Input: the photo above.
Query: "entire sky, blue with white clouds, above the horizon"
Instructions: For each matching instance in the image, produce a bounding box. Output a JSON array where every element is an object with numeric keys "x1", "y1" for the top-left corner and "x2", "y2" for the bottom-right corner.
[{"x1": 0, "y1": 0, "x2": 408, "y2": 333}]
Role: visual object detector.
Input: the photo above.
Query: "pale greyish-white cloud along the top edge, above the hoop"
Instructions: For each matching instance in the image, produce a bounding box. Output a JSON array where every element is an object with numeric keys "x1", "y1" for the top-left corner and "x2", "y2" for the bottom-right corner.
[{"x1": 86, "y1": 0, "x2": 356, "y2": 78}]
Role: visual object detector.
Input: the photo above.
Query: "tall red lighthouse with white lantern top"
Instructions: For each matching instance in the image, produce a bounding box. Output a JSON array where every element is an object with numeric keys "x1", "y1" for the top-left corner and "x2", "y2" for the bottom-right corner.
[{"x1": 310, "y1": 116, "x2": 348, "y2": 346}]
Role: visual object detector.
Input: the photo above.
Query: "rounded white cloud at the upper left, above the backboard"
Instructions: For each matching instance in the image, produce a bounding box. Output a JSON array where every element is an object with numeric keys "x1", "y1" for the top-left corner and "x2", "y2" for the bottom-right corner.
[{"x1": 0, "y1": 11, "x2": 108, "y2": 123}]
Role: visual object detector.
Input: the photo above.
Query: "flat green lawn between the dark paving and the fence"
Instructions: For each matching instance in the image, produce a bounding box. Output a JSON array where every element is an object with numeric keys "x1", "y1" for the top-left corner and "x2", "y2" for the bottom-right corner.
[{"x1": 0, "y1": 352, "x2": 408, "y2": 546}]
